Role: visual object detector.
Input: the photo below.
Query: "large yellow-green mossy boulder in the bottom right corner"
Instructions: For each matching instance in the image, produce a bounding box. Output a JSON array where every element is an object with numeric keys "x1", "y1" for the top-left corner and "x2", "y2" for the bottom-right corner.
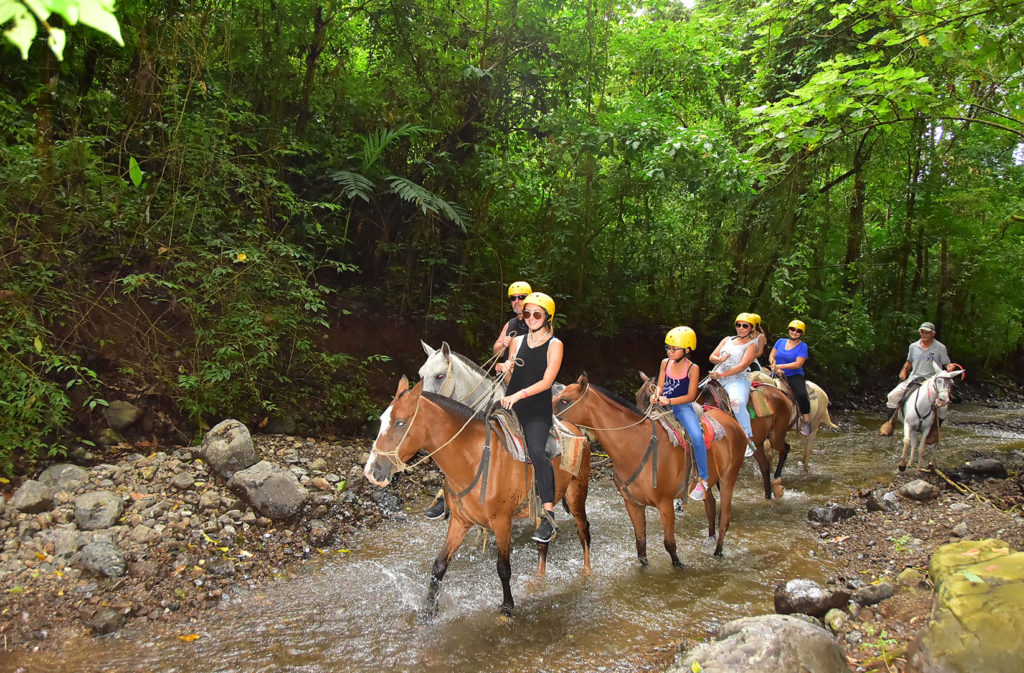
[{"x1": 906, "y1": 540, "x2": 1024, "y2": 673}]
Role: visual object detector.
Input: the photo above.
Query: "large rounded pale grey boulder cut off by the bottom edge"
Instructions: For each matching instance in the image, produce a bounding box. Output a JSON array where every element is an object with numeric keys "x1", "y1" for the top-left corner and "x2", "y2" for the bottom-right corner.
[{"x1": 668, "y1": 615, "x2": 850, "y2": 673}]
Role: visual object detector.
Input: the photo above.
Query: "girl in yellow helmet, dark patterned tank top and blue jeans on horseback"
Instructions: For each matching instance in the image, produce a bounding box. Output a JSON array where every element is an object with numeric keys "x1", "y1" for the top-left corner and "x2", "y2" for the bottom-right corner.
[{"x1": 650, "y1": 326, "x2": 708, "y2": 500}]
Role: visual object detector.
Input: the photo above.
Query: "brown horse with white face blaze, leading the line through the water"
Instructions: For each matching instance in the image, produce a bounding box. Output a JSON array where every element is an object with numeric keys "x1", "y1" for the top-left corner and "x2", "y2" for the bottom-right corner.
[{"x1": 364, "y1": 376, "x2": 591, "y2": 618}]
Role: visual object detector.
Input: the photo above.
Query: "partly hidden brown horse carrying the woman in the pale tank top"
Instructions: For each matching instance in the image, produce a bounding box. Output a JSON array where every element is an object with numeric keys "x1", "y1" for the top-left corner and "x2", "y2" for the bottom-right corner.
[{"x1": 637, "y1": 372, "x2": 793, "y2": 500}]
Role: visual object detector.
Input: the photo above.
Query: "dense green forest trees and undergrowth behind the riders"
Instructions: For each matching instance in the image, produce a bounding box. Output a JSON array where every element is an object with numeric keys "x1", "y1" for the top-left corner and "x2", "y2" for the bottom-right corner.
[{"x1": 0, "y1": 0, "x2": 1024, "y2": 467}]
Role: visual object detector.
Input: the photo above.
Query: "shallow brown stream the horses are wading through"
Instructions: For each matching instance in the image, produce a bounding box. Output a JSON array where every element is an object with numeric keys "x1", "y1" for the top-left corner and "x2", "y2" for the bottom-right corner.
[{"x1": 0, "y1": 406, "x2": 1024, "y2": 673}]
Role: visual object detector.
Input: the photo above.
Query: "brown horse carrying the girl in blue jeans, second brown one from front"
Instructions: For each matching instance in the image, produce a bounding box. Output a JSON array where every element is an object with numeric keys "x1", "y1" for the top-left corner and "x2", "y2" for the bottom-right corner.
[{"x1": 554, "y1": 375, "x2": 746, "y2": 567}]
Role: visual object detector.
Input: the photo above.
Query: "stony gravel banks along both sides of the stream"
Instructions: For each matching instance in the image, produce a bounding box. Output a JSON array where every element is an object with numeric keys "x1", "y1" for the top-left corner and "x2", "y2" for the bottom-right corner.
[{"x1": 0, "y1": 417, "x2": 1024, "y2": 671}]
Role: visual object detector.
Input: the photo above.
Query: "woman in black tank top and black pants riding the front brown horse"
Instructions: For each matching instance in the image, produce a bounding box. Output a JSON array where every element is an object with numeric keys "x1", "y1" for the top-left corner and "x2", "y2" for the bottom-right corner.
[{"x1": 495, "y1": 292, "x2": 564, "y2": 542}]
